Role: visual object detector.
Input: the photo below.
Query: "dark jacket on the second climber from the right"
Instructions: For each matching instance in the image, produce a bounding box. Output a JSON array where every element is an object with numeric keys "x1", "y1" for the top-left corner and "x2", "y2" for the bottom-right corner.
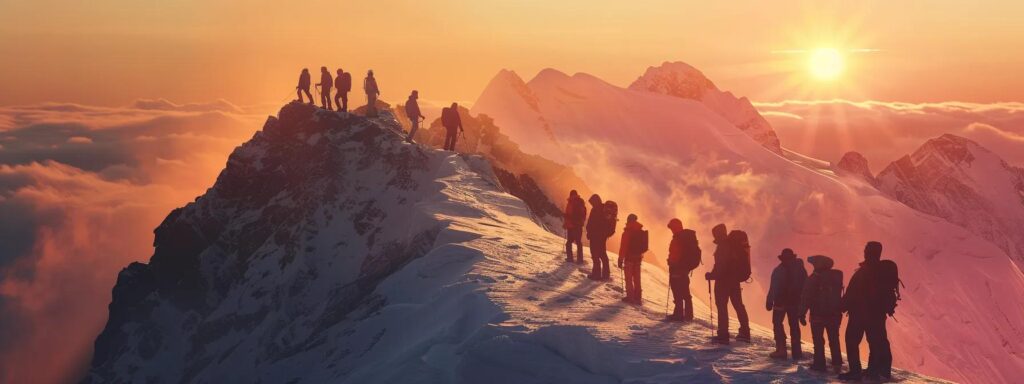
[{"x1": 800, "y1": 256, "x2": 843, "y2": 323}]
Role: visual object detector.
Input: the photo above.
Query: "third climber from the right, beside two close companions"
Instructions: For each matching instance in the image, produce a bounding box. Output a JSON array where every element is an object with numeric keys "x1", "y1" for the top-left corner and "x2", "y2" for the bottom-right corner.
[{"x1": 765, "y1": 248, "x2": 807, "y2": 360}]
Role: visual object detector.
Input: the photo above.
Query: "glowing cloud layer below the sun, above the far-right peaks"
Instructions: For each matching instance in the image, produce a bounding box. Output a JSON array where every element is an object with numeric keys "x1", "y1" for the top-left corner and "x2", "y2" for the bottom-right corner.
[{"x1": 756, "y1": 100, "x2": 1024, "y2": 173}]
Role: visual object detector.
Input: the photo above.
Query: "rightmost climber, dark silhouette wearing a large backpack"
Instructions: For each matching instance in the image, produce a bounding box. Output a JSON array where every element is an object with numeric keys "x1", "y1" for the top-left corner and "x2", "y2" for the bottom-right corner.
[{"x1": 839, "y1": 242, "x2": 900, "y2": 381}]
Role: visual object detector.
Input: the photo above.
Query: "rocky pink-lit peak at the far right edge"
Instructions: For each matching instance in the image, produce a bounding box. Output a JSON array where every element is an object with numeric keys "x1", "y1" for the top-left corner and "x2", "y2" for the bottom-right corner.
[{"x1": 878, "y1": 134, "x2": 1024, "y2": 265}]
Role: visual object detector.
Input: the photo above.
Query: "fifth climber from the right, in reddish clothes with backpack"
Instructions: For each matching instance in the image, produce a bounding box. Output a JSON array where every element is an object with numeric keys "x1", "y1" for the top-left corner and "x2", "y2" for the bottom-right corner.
[{"x1": 666, "y1": 219, "x2": 700, "y2": 322}]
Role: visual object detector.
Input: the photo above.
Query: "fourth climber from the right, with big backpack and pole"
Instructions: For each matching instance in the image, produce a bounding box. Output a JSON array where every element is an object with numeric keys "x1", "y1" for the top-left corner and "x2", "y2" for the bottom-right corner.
[{"x1": 705, "y1": 224, "x2": 751, "y2": 344}]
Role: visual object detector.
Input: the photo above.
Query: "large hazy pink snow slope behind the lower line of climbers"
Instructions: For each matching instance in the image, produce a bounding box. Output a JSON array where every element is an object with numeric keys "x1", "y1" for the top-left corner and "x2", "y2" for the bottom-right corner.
[{"x1": 473, "y1": 70, "x2": 1024, "y2": 383}]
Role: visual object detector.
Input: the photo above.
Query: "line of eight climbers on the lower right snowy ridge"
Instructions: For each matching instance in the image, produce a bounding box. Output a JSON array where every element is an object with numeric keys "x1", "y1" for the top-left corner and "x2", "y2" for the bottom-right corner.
[{"x1": 563, "y1": 190, "x2": 900, "y2": 381}]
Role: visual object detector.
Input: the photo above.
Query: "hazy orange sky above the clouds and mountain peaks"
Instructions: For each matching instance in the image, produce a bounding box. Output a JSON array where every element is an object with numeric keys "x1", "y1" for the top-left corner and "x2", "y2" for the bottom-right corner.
[{"x1": 0, "y1": 0, "x2": 1024, "y2": 104}]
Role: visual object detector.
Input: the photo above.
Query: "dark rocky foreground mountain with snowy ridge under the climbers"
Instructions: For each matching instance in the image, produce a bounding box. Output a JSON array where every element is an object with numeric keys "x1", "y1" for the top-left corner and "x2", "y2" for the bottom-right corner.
[{"x1": 83, "y1": 103, "x2": 938, "y2": 384}]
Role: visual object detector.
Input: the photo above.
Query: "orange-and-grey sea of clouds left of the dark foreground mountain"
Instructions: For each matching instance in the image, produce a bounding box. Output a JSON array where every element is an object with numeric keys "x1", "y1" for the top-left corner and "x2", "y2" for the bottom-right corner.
[{"x1": 0, "y1": 100, "x2": 265, "y2": 383}]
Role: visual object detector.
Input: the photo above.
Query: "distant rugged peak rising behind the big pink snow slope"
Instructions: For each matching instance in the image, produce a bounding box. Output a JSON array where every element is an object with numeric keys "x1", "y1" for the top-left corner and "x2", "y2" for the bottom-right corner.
[{"x1": 629, "y1": 61, "x2": 782, "y2": 154}]
